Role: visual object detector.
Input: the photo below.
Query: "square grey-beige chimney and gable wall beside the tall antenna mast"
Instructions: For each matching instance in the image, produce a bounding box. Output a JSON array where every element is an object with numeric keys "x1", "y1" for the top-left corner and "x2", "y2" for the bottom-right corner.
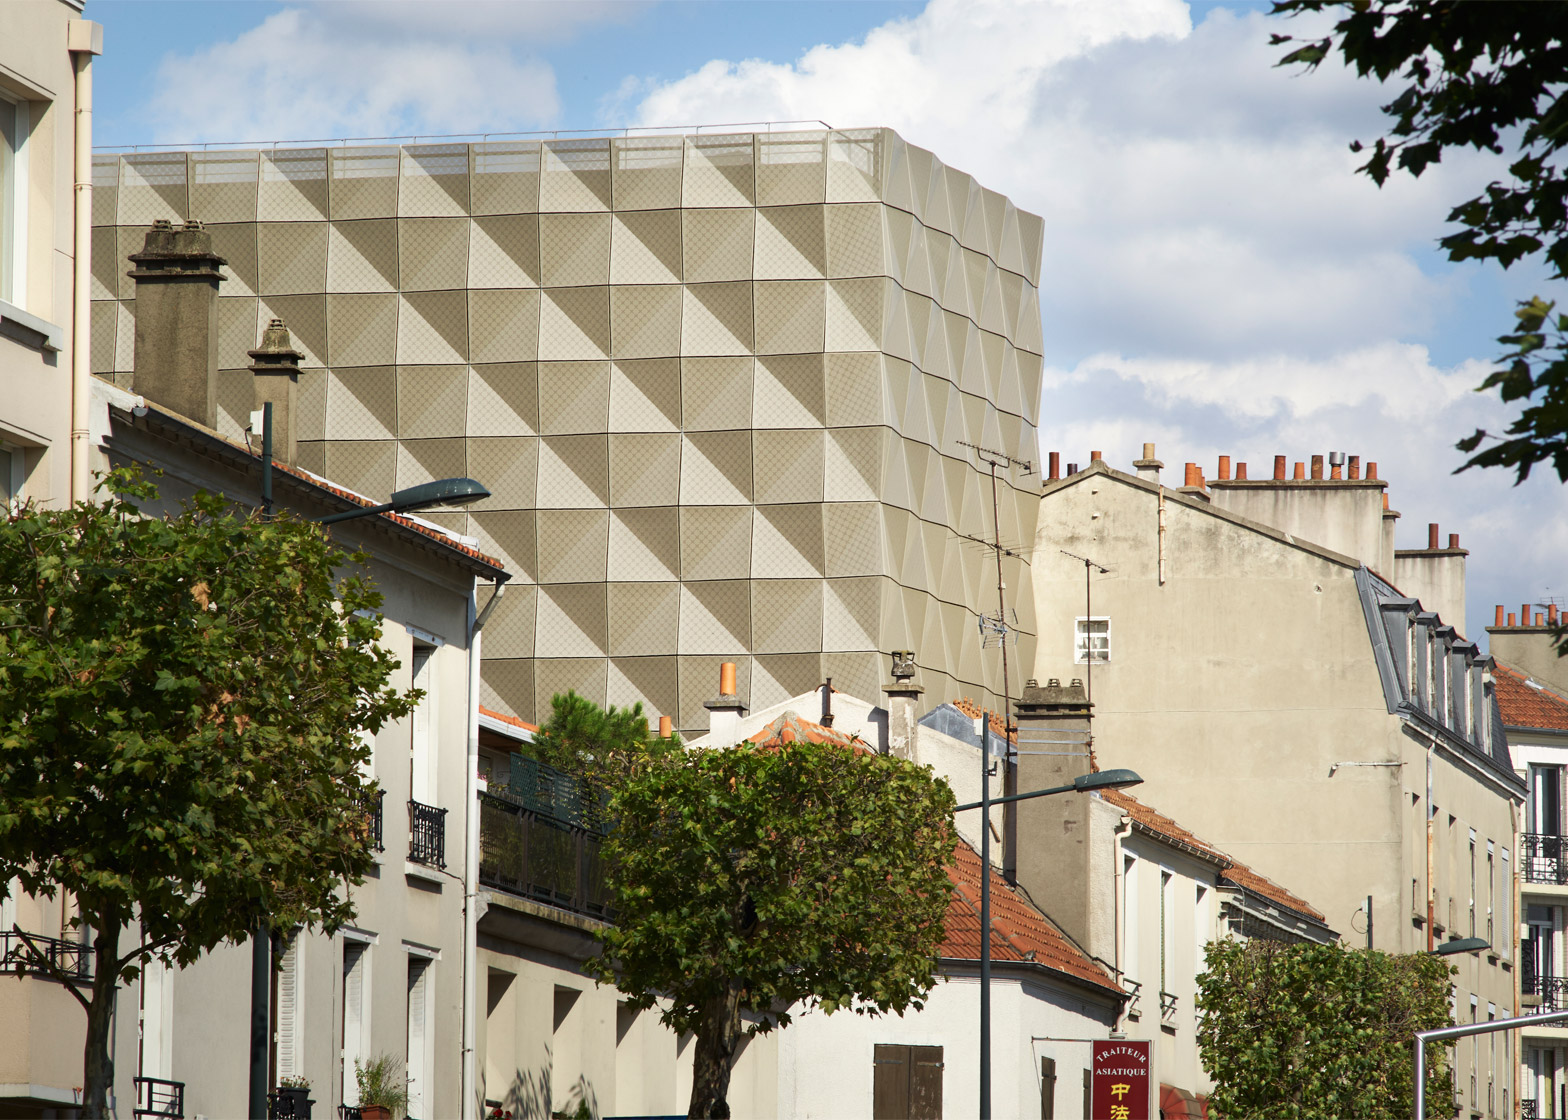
[{"x1": 1014, "y1": 679, "x2": 1121, "y2": 960}]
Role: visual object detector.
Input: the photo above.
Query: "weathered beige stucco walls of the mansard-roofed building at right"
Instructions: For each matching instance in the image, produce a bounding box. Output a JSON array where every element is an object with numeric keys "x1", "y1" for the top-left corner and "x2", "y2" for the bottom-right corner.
[{"x1": 1033, "y1": 469, "x2": 1515, "y2": 1110}]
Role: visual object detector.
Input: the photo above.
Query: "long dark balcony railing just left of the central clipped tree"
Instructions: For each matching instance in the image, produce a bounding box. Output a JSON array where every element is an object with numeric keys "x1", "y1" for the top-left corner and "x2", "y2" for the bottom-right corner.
[{"x1": 478, "y1": 794, "x2": 612, "y2": 918}]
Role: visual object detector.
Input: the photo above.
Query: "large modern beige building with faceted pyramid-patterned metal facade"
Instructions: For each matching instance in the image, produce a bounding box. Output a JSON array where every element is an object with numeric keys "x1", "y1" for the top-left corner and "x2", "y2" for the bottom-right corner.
[{"x1": 93, "y1": 129, "x2": 1041, "y2": 729}]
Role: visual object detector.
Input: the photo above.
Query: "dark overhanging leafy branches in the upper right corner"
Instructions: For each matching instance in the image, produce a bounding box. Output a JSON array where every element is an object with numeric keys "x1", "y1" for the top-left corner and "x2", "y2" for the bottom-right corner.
[{"x1": 1273, "y1": 0, "x2": 1568, "y2": 482}]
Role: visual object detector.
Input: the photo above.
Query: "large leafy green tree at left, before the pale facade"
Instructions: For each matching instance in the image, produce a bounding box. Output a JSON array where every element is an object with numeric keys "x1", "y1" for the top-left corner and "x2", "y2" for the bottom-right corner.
[{"x1": 0, "y1": 472, "x2": 416, "y2": 1117}]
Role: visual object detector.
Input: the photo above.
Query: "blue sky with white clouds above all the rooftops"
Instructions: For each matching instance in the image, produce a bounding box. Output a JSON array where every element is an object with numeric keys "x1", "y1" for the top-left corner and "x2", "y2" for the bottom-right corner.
[{"x1": 88, "y1": 0, "x2": 1568, "y2": 637}]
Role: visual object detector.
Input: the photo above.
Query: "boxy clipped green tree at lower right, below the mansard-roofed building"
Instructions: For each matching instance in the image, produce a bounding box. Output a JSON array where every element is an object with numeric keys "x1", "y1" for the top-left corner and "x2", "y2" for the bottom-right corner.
[{"x1": 1198, "y1": 941, "x2": 1455, "y2": 1120}]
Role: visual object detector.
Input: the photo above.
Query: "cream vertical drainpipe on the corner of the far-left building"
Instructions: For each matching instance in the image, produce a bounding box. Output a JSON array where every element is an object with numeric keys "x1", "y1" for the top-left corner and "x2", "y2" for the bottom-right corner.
[{"x1": 66, "y1": 19, "x2": 103, "y2": 502}]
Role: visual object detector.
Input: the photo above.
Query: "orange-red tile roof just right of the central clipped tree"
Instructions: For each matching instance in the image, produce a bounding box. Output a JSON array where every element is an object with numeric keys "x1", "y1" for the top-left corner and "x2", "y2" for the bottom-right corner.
[{"x1": 941, "y1": 839, "x2": 1123, "y2": 995}]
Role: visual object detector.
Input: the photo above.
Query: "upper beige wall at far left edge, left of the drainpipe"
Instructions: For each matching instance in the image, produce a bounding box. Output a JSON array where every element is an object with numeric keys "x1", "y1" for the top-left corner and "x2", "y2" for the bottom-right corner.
[{"x1": 0, "y1": 0, "x2": 82, "y2": 504}]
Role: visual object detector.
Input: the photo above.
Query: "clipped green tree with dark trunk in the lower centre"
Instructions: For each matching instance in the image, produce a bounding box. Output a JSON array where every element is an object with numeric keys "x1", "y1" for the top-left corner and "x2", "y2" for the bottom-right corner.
[{"x1": 588, "y1": 742, "x2": 955, "y2": 1117}]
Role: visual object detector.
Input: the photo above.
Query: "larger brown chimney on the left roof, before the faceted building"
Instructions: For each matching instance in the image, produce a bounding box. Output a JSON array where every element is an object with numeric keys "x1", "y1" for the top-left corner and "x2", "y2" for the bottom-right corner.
[{"x1": 125, "y1": 218, "x2": 229, "y2": 428}]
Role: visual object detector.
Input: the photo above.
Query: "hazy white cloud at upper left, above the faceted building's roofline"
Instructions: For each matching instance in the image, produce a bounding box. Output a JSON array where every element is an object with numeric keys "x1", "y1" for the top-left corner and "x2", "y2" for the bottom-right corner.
[{"x1": 151, "y1": 0, "x2": 641, "y2": 143}]
